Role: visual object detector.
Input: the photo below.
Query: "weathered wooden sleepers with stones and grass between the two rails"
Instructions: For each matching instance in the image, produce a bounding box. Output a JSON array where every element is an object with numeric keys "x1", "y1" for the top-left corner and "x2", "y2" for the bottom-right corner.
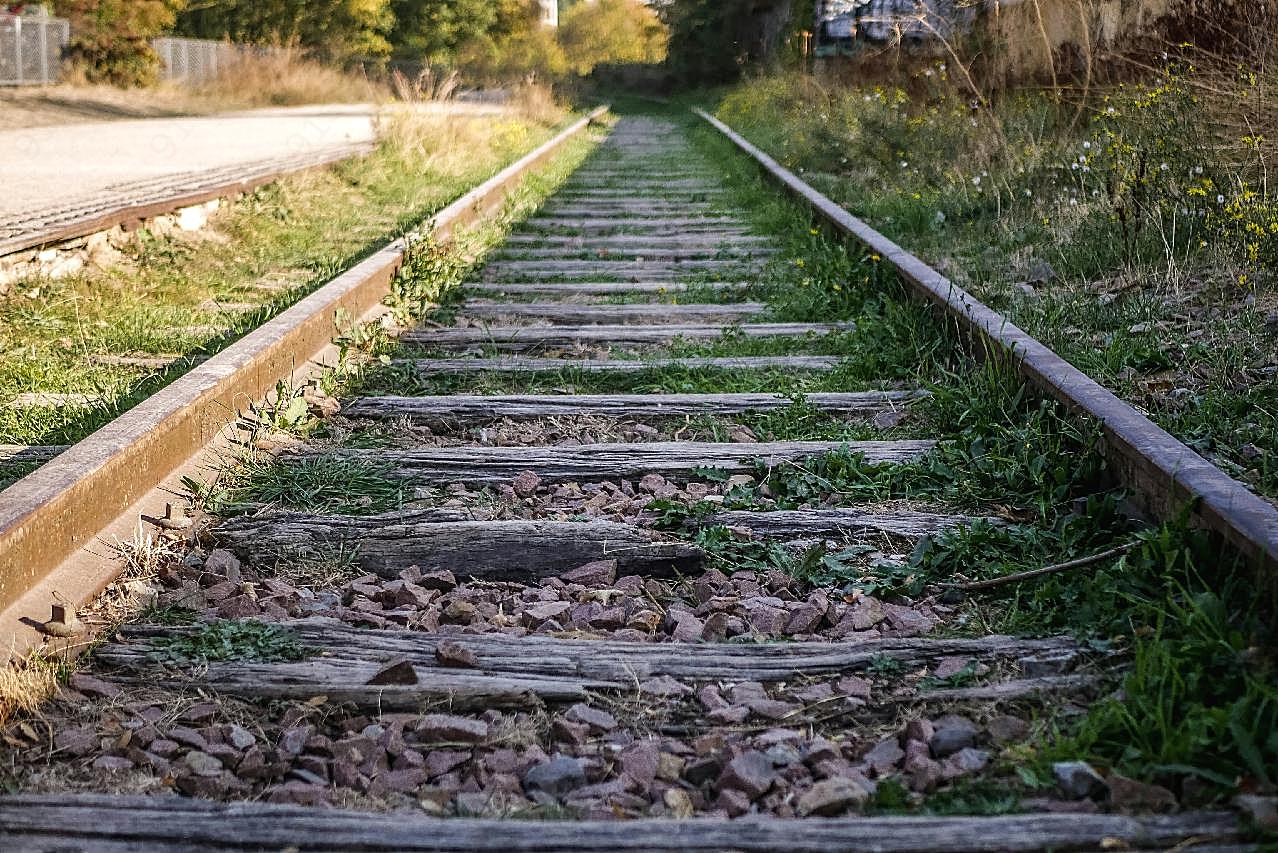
[{"x1": 0, "y1": 118, "x2": 1262, "y2": 850}]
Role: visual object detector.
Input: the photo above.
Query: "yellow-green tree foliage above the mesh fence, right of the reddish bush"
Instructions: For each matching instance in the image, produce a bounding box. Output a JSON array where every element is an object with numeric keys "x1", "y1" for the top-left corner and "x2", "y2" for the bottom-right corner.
[{"x1": 178, "y1": 0, "x2": 395, "y2": 61}]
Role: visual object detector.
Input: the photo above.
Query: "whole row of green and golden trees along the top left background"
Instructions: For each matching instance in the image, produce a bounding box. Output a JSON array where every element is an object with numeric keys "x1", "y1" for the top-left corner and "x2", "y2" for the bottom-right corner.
[{"x1": 55, "y1": 0, "x2": 679, "y2": 84}]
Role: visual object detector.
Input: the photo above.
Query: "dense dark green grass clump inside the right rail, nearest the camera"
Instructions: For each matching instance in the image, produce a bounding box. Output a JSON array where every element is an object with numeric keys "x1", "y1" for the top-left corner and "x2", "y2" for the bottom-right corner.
[{"x1": 1052, "y1": 524, "x2": 1278, "y2": 795}]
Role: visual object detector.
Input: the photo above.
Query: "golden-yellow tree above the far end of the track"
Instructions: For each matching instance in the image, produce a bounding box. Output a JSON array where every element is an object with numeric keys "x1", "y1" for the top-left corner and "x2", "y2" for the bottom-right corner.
[{"x1": 558, "y1": 0, "x2": 670, "y2": 75}]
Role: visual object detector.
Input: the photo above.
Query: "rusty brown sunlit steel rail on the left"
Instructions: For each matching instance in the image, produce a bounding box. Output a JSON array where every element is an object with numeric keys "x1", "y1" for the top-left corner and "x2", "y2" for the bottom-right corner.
[{"x1": 0, "y1": 107, "x2": 607, "y2": 657}]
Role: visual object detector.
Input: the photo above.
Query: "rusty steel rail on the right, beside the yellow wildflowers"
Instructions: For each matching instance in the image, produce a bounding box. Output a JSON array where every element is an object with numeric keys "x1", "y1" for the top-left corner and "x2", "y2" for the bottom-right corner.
[{"x1": 694, "y1": 109, "x2": 1278, "y2": 570}]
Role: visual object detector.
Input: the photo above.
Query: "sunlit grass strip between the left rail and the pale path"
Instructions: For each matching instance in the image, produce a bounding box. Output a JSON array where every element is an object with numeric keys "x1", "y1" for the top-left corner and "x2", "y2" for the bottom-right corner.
[{"x1": 0, "y1": 109, "x2": 569, "y2": 445}]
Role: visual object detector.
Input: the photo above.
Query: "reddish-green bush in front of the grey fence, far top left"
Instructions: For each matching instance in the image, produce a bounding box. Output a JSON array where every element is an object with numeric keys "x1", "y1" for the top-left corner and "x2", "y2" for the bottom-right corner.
[{"x1": 54, "y1": 0, "x2": 185, "y2": 86}]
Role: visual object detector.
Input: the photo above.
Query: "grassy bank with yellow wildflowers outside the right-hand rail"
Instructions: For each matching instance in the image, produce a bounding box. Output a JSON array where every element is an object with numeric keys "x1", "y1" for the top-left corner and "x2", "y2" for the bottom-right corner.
[{"x1": 716, "y1": 69, "x2": 1278, "y2": 500}]
